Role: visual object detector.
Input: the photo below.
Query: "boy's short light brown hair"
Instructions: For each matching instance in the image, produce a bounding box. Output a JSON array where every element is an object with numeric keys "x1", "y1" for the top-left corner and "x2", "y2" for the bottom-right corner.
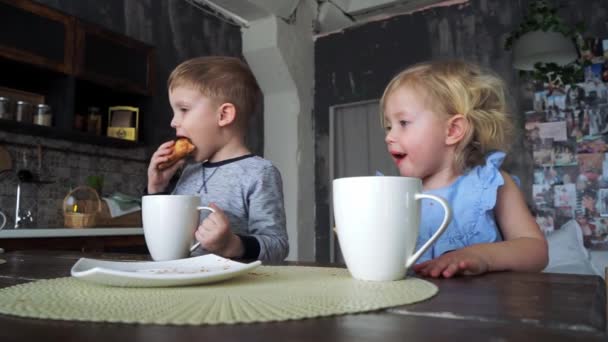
[{"x1": 167, "y1": 56, "x2": 262, "y2": 122}]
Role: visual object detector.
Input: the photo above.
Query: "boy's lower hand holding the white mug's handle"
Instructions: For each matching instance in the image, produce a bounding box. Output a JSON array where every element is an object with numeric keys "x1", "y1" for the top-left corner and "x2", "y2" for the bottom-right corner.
[{"x1": 194, "y1": 203, "x2": 244, "y2": 258}]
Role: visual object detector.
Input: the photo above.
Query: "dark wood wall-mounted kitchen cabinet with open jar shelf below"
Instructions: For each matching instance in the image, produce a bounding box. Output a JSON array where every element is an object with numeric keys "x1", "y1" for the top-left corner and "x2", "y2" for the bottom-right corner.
[{"x1": 0, "y1": 0, "x2": 155, "y2": 147}]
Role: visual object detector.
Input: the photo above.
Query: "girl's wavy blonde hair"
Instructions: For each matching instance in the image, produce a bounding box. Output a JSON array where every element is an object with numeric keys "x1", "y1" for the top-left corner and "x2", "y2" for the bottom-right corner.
[{"x1": 380, "y1": 61, "x2": 513, "y2": 171}]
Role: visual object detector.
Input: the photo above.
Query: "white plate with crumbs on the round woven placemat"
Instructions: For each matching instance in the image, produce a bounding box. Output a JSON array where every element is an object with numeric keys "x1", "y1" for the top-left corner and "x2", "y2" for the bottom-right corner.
[{"x1": 71, "y1": 254, "x2": 262, "y2": 287}]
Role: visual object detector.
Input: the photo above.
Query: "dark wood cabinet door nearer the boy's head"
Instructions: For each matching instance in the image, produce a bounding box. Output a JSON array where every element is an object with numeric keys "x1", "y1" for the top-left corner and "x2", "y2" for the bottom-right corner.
[{"x1": 75, "y1": 22, "x2": 154, "y2": 95}]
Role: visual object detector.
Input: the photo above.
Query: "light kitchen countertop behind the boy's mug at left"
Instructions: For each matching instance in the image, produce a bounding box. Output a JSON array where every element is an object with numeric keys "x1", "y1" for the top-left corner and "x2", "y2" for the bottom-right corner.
[{"x1": 0, "y1": 227, "x2": 144, "y2": 239}]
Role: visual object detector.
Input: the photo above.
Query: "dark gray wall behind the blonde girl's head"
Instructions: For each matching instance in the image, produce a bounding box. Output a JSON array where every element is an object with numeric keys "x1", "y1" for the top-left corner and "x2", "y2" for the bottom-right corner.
[{"x1": 314, "y1": 0, "x2": 608, "y2": 261}]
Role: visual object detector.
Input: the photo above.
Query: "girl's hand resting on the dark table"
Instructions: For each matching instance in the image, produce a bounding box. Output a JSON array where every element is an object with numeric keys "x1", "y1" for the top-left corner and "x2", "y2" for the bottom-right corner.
[{"x1": 414, "y1": 248, "x2": 488, "y2": 278}]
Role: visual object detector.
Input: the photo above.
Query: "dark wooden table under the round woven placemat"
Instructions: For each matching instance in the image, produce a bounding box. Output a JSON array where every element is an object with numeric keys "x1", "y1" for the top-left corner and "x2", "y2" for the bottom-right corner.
[{"x1": 0, "y1": 251, "x2": 608, "y2": 342}]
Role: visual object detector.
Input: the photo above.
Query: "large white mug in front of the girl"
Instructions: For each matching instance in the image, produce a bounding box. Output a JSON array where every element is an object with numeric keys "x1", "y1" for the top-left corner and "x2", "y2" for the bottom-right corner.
[{"x1": 333, "y1": 176, "x2": 452, "y2": 281}]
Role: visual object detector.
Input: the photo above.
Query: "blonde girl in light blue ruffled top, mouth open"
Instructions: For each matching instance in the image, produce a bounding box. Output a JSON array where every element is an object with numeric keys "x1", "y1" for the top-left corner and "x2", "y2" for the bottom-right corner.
[{"x1": 380, "y1": 61, "x2": 548, "y2": 278}]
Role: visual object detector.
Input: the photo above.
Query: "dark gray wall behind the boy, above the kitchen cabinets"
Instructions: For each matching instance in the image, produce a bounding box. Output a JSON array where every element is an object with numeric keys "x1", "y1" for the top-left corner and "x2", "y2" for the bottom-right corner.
[{"x1": 32, "y1": 0, "x2": 263, "y2": 153}]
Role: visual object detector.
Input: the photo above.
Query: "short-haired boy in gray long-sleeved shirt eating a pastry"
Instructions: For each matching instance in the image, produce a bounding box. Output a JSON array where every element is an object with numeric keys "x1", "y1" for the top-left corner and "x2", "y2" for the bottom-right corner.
[{"x1": 147, "y1": 56, "x2": 289, "y2": 261}]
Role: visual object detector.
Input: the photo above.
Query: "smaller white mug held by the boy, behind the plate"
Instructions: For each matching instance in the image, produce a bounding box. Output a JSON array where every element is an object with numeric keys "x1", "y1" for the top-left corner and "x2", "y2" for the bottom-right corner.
[{"x1": 142, "y1": 195, "x2": 215, "y2": 261}]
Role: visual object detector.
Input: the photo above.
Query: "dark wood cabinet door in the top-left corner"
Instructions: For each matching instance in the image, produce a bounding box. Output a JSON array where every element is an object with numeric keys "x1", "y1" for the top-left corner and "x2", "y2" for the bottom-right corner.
[{"x1": 0, "y1": 0, "x2": 75, "y2": 74}]
